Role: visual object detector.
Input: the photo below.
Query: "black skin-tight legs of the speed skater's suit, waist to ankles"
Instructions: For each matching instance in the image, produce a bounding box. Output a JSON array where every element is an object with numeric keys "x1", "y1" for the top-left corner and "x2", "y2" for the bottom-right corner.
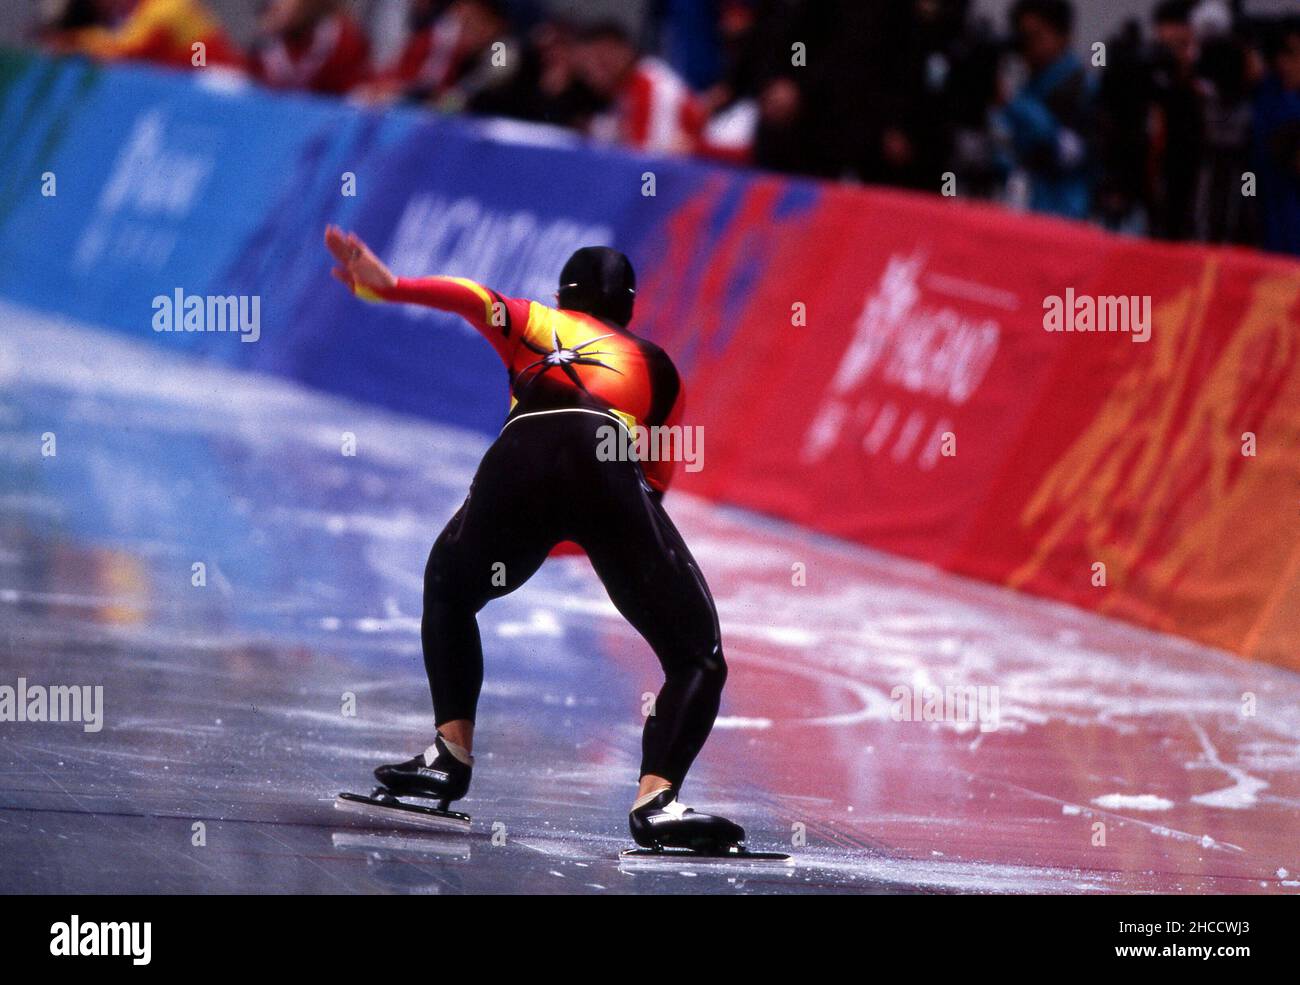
[{"x1": 421, "y1": 412, "x2": 727, "y2": 786}]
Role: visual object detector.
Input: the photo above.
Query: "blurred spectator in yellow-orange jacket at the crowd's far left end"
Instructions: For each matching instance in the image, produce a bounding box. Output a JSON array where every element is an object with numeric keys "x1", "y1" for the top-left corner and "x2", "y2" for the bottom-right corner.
[{"x1": 47, "y1": 0, "x2": 243, "y2": 69}]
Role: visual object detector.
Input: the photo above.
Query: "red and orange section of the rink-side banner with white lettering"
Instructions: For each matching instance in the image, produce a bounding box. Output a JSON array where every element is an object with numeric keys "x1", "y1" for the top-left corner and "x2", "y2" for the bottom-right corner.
[{"x1": 641, "y1": 181, "x2": 1300, "y2": 669}]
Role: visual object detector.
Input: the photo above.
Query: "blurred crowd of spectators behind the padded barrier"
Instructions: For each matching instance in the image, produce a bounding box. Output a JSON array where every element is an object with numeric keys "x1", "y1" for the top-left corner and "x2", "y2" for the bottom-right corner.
[{"x1": 25, "y1": 0, "x2": 1300, "y2": 255}]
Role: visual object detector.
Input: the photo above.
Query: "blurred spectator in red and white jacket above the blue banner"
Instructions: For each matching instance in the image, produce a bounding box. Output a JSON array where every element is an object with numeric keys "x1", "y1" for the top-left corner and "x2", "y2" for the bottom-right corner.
[{"x1": 579, "y1": 22, "x2": 703, "y2": 153}]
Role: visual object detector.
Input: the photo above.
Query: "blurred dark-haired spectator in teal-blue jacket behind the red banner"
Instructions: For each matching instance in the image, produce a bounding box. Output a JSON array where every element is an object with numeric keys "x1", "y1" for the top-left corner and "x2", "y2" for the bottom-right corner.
[{"x1": 1002, "y1": 0, "x2": 1092, "y2": 218}]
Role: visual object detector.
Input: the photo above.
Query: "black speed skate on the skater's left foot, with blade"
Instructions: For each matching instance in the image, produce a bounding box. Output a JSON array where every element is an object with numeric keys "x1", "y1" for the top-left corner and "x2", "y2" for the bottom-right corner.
[{"x1": 334, "y1": 734, "x2": 473, "y2": 832}]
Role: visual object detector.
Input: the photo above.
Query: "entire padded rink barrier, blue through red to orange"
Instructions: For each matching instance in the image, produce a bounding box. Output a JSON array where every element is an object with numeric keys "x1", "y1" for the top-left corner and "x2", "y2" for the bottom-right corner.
[{"x1": 0, "y1": 52, "x2": 1300, "y2": 669}]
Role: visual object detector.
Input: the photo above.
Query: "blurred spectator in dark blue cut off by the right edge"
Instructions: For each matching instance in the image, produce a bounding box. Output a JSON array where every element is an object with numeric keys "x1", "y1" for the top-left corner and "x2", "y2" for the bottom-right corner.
[{"x1": 1255, "y1": 21, "x2": 1300, "y2": 255}]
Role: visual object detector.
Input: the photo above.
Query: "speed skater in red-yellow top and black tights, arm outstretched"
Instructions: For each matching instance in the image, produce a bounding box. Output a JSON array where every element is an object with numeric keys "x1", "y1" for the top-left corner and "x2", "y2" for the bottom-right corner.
[{"x1": 325, "y1": 226, "x2": 745, "y2": 850}]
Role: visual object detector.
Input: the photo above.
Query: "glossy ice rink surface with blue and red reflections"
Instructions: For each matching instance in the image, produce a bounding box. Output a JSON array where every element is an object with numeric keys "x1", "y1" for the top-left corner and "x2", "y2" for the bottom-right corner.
[{"x1": 0, "y1": 304, "x2": 1300, "y2": 893}]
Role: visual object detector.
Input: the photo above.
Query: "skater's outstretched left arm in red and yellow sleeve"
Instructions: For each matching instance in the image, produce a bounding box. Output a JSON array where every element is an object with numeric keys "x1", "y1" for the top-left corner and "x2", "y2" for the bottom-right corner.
[{"x1": 325, "y1": 226, "x2": 530, "y2": 361}]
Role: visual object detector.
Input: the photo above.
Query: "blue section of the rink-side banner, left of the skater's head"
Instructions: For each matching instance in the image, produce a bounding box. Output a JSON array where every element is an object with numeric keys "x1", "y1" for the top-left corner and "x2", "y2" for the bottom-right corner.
[{"x1": 0, "y1": 53, "x2": 746, "y2": 431}]
